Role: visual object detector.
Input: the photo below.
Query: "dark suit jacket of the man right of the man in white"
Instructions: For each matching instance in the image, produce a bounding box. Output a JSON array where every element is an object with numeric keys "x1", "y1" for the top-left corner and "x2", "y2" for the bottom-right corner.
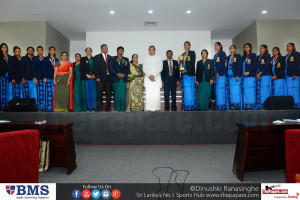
[{"x1": 160, "y1": 60, "x2": 180, "y2": 85}]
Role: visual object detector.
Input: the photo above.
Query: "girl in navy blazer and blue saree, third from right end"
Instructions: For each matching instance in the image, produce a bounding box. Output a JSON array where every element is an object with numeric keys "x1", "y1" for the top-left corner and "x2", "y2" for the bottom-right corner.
[{"x1": 256, "y1": 44, "x2": 272, "y2": 109}]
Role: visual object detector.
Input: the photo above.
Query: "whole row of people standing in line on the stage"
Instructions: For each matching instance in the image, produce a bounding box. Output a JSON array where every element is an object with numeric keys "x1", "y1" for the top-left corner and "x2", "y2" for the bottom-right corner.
[{"x1": 0, "y1": 41, "x2": 300, "y2": 112}]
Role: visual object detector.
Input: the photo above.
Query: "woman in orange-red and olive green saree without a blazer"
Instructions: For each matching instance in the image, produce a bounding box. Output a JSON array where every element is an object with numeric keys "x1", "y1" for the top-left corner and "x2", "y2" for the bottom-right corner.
[{"x1": 53, "y1": 52, "x2": 73, "y2": 112}]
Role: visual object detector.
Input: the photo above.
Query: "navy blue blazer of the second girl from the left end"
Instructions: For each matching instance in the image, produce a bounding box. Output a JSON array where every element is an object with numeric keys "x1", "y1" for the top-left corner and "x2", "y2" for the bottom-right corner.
[{"x1": 8, "y1": 56, "x2": 22, "y2": 82}]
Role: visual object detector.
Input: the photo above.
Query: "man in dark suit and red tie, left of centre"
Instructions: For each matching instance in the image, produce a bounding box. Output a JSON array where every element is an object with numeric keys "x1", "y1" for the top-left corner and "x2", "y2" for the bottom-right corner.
[{"x1": 94, "y1": 44, "x2": 113, "y2": 111}]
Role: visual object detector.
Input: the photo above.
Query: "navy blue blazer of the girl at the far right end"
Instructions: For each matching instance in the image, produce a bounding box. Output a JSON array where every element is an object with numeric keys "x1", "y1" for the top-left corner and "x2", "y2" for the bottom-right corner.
[{"x1": 285, "y1": 51, "x2": 300, "y2": 76}]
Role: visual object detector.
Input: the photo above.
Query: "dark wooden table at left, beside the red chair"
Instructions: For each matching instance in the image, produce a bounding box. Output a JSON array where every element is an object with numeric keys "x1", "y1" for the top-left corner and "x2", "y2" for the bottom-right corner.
[{"x1": 0, "y1": 122, "x2": 77, "y2": 175}]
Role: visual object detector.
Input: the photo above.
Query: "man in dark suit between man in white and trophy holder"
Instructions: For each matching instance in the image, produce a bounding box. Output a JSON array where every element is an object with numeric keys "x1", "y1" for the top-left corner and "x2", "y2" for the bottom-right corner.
[{"x1": 161, "y1": 50, "x2": 180, "y2": 111}]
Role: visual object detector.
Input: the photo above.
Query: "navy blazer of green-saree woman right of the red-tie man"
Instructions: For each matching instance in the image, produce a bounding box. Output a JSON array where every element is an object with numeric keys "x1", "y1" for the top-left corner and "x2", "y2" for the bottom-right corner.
[{"x1": 108, "y1": 56, "x2": 130, "y2": 82}]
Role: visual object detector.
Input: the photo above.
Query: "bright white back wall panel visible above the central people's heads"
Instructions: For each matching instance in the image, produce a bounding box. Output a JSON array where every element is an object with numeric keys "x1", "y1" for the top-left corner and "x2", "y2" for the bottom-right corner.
[{"x1": 86, "y1": 31, "x2": 211, "y2": 62}]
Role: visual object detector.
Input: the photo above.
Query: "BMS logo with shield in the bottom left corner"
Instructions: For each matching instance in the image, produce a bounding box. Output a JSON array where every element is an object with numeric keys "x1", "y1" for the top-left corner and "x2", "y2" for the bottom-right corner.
[{"x1": 6, "y1": 185, "x2": 49, "y2": 195}]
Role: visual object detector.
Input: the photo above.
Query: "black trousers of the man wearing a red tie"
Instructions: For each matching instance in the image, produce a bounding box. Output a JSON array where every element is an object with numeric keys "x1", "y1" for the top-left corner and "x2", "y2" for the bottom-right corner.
[{"x1": 97, "y1": 77, "x2": 113, "y2": 111}]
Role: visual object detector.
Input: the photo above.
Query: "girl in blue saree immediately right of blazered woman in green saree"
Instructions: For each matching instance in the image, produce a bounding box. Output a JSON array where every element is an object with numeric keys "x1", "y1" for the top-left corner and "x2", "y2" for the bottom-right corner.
[{"x1": 214, "y1": 42, "x2": 229, "y2": 110}]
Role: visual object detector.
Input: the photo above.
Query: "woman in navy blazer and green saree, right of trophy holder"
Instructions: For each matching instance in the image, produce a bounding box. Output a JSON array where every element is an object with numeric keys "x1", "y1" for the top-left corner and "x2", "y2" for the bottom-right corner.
[{"x1": 196, "y1": 49, "x2": 214, "y2": 111}]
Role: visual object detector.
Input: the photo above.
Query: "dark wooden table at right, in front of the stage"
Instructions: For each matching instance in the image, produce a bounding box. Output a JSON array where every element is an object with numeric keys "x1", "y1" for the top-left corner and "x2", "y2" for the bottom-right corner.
[{"x1": 233, "y1": 122, "x2": 300, "y2": 181}]
